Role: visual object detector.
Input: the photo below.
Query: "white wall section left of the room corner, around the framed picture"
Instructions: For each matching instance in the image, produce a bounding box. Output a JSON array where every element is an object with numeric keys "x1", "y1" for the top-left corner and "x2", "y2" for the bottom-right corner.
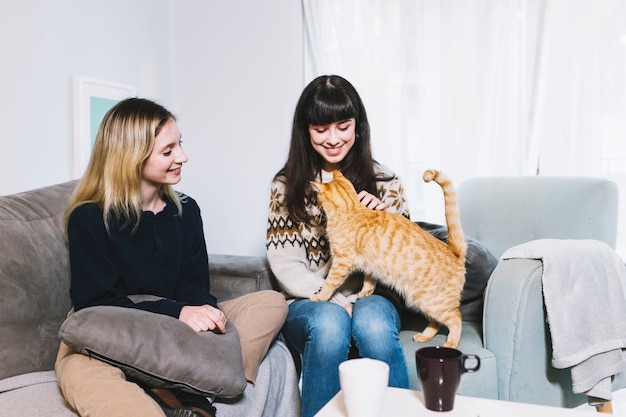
[{"x1": 0, "y1": 0, "x2": 173, "y2": 194}]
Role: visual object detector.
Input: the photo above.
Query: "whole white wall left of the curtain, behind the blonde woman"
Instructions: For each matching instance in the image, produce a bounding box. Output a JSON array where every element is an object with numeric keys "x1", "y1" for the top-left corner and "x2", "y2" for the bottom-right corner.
[{"x1": 0, "y1": 0, "x2": 303, "y2": 255}]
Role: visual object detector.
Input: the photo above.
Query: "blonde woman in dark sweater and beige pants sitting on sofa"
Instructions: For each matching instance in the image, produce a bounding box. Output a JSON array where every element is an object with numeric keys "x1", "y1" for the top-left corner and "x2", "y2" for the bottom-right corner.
[{"x1": 56, "y1": 98, "x2": 287, "y2": 417}]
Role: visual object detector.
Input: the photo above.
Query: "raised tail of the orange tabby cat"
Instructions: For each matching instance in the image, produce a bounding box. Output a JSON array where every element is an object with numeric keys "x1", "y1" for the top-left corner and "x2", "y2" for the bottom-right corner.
[{"x1": 422, "y1": 169, "x2": 467, "y2": 262}]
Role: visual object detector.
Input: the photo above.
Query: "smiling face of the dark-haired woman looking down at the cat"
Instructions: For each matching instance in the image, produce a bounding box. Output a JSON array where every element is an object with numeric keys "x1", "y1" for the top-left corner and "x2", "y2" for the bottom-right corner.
[{"x1": 309, "y1": 118, "x2": 356, "y2": 171}]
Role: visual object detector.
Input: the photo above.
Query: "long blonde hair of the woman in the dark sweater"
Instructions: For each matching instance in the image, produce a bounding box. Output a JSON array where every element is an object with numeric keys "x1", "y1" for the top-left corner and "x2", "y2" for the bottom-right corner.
[{"x1": 65, "y1": 98, "x2": 182, "y2": 233}]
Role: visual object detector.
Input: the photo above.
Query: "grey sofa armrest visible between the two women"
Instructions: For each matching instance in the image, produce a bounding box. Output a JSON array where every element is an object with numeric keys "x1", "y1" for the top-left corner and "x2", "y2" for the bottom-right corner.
[{"x1": 209, "y1": 254, "x2": 279, "y2": 302}]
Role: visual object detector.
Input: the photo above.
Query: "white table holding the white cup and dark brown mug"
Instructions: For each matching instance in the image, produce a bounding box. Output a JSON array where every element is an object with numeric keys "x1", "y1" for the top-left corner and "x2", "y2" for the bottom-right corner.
[{"x1": 315, "y1": 388, "x2": 617, "y2": 417}]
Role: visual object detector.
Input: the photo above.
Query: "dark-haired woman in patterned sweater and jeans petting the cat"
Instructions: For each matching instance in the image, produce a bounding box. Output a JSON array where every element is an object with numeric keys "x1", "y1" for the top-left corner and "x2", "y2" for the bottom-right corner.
[{"x1": 266, "y1": 75, "x2": 409, "y2": 417}]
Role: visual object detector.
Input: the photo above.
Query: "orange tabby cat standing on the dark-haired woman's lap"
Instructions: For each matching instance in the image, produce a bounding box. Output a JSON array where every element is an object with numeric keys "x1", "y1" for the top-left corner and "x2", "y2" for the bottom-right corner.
[{"x1": 311, "y1": 170, "x2": 467, "y2": 348}]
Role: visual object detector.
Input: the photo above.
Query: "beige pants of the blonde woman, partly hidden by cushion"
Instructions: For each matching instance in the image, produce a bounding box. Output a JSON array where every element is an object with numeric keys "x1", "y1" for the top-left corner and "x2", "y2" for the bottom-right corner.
[{"x1": 55, "y1": 291, "x2": 287, "y2": 417}]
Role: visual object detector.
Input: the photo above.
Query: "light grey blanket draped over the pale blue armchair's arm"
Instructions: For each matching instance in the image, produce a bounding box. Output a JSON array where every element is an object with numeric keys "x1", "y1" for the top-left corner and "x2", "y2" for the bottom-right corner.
[{"x1": 502, "y1": 239, "x2": 626, "y2": 401}]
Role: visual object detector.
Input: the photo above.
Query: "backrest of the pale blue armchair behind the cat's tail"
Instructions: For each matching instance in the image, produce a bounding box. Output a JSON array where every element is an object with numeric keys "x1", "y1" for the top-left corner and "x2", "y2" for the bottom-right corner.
[{"x1": 458, "y1": 176, "x2": 619, "y2": 258}]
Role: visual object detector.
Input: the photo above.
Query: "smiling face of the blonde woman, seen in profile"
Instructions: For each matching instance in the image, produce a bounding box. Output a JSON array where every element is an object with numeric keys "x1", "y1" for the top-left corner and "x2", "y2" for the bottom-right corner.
[{"x1": 141, "y1": 119, "x2": 188, "y2": 189}]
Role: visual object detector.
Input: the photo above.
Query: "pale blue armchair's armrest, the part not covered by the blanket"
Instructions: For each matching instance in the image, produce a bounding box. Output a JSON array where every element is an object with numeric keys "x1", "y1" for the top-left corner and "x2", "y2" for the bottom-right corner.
[{"x1": 483, "y1": 259, "x2": 587, "y2": 407}]
